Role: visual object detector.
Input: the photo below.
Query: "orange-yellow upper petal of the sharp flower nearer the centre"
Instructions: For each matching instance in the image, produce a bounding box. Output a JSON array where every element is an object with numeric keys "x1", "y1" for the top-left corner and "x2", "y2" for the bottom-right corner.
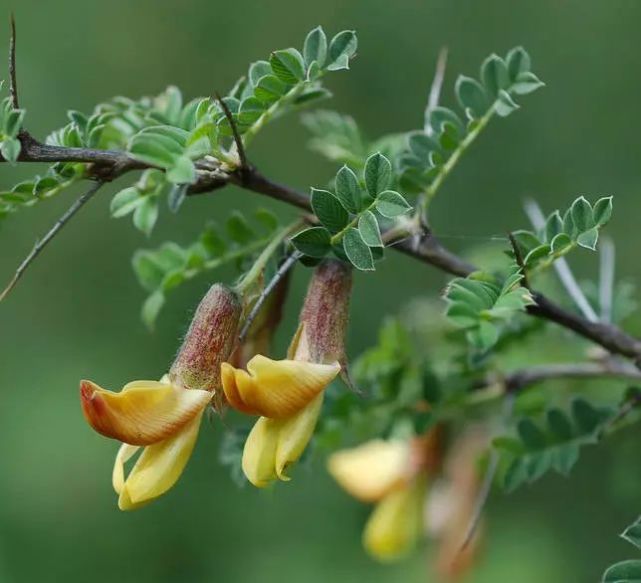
[{"x1": 222, "y1": 355, "x2": 341, "y2": 419}]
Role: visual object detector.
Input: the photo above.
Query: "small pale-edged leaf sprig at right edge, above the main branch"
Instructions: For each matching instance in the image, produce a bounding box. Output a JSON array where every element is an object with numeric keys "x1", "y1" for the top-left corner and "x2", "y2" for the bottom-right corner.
[{"x1": 513, "y1": 196, "x2": 612, "y2": 272}]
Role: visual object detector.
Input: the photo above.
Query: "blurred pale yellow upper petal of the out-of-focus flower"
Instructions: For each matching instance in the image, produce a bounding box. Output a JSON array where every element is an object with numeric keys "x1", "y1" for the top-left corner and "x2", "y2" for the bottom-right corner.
[{"x1": 327, "y1": 439, "x2": 411, "y2": 502}]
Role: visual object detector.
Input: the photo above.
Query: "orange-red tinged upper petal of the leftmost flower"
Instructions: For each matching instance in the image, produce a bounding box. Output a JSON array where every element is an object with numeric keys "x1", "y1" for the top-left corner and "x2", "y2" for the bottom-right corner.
[{"x1": 80, "y1": 381, "x2": 212, "y2": 445}]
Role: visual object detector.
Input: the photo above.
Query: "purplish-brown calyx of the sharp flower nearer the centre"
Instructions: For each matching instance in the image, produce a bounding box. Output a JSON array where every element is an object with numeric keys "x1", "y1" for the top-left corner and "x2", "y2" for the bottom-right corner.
[{"x1": 290, "y1": 259, "x2": 352, "y2": 364}]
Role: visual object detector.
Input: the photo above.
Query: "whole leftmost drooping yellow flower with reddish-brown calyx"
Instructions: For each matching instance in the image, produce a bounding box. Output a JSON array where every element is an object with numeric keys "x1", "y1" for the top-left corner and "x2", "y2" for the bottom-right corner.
[{"x1": 80, "y1": 285, "x2": 241, "y2": 510}]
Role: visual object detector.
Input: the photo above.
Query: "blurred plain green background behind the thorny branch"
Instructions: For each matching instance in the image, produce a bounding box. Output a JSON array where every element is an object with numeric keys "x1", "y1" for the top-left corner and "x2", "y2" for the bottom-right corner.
[{"x1": 0, "y1": 0, "x2": 641, "y2": 583}]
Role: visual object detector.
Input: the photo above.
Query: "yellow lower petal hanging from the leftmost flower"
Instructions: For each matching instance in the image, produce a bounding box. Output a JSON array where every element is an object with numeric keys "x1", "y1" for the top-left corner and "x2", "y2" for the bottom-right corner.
[{"x1": 118, "y1": 411, "x2": 203, "y2": 510}]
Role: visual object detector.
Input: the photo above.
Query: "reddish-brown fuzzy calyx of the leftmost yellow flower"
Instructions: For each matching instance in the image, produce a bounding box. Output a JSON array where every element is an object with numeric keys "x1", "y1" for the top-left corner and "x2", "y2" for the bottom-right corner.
[{"x1": 169, "y1": 283, "x2": 242, "y2": 391}]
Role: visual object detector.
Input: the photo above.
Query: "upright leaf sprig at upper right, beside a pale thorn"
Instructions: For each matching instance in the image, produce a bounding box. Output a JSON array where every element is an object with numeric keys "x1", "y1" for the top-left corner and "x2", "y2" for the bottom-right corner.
[{"x1": 399, "y1": 47, "x2": 543, "y2": 192}]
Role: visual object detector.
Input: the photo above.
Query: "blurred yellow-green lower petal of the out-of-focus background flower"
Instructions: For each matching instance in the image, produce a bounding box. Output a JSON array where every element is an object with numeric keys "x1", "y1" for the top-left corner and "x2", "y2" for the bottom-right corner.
[{"x1": 363, "y1": 479, "x2": 425, "y2": 562}]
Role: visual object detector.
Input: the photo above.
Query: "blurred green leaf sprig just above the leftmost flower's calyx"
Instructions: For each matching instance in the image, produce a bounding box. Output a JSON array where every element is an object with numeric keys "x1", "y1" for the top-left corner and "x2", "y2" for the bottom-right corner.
[{"x1": 133, "y1": 209, "x2": 278, "y2": 327}]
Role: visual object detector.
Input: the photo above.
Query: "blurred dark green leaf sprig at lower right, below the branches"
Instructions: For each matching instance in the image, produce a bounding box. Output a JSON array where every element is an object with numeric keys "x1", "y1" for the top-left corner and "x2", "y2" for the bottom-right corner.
[{"x1": 493, "y1": 398, "x2": 613, "y2": 492}]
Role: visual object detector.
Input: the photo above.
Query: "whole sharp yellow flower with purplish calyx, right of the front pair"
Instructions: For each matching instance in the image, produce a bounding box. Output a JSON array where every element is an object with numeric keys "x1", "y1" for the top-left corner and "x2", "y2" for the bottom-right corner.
[{"x1": 222, "y1": 261, "x2": 351, "y2": 488}]
